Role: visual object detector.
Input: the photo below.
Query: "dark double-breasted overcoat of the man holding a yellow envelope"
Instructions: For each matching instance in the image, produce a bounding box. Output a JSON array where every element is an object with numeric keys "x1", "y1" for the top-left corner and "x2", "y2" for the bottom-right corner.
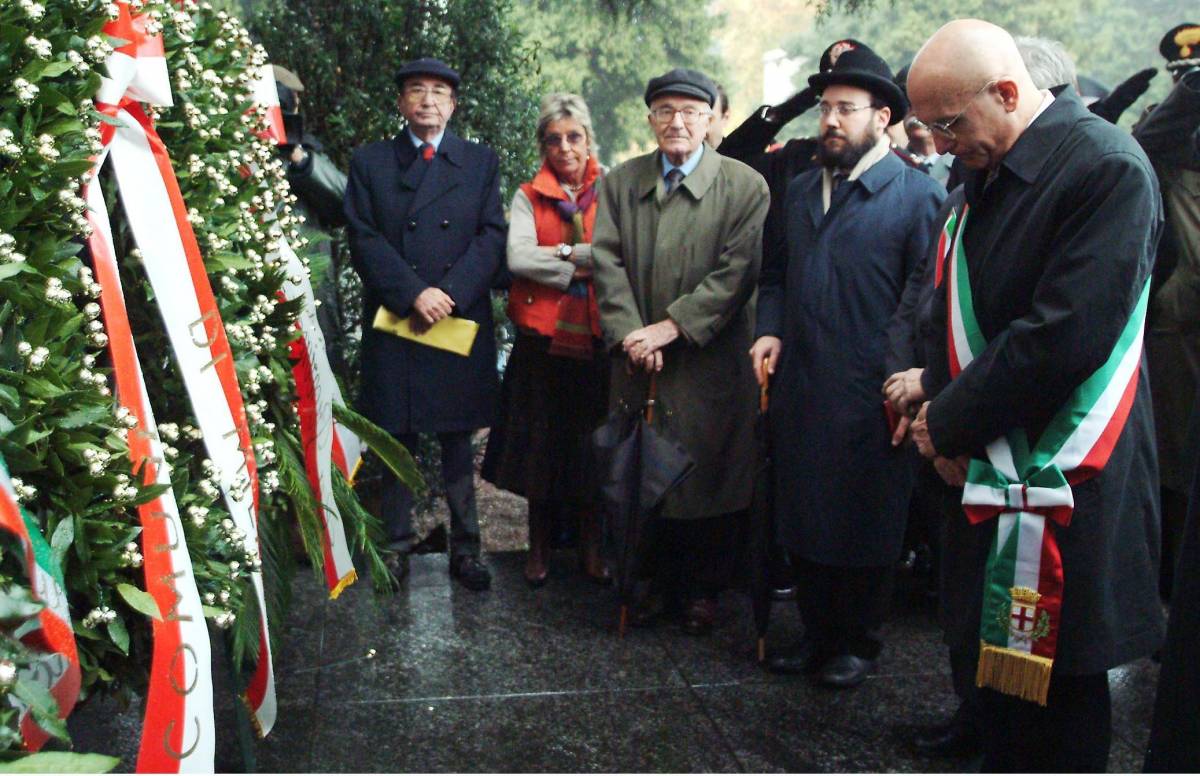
[{"x1": 344, "y1": 130, "x2": 506, "y2": 433}]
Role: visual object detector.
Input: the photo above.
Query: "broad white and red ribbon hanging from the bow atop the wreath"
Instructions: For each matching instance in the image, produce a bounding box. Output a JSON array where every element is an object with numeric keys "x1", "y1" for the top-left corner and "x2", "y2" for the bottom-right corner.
[{"x1": 96, "y1": 2, "x2": 276, "y2": 735}]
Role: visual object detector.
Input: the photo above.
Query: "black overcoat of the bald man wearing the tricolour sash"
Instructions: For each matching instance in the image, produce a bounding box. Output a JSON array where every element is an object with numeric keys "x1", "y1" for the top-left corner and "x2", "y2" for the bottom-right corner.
[{"x1": 922, "y1": 89, "x2": 1163, "y2": 674}]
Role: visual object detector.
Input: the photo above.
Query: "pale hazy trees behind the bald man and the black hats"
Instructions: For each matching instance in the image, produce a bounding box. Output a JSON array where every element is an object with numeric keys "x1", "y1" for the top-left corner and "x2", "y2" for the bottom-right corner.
[{"x1": 784, "y1": 0, "x2": 1194, "y2": 132}]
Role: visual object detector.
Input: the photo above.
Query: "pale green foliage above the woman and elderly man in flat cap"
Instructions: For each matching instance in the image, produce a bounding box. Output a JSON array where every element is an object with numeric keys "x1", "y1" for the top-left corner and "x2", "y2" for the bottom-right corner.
[{"x1": 512, "y1": 0, "x2": 724, "y2": 164}]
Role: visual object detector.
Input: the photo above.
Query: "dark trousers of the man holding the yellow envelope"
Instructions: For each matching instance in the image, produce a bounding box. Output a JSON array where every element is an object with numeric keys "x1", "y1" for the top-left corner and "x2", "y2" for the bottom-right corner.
[{"x1": 380, "y1": 431, "x2": 479, "y2": 555}]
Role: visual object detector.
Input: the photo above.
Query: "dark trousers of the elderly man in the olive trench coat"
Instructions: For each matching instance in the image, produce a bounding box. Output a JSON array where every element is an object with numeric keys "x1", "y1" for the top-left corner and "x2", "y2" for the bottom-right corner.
[{"x1": 638, "y1": 512, "x2": 745, "y2": 601}]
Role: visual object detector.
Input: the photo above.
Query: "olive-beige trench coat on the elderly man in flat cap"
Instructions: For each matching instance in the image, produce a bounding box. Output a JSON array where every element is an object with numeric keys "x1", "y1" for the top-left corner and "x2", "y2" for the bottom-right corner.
[{"x1": 592, "y1": 146, "x2": 770, "y2": 519}]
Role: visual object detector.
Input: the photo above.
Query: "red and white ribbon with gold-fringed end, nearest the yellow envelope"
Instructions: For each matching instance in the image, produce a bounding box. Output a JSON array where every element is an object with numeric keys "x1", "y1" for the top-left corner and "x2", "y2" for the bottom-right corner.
[{"x1": 278, "y1": 236, "x2": 361, "y2": 598}]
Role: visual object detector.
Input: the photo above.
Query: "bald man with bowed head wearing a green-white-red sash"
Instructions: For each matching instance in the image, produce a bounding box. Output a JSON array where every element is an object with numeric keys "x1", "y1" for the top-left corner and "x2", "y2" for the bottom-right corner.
[{"x1": 908, "y1": 19, "x2": 1163, "y2": 772}]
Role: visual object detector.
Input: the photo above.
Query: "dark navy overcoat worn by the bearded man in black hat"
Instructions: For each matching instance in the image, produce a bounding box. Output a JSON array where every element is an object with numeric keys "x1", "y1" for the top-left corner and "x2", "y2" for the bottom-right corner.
[{"x1": 756, "y1": 154, "x2": 946, "y2": 566}]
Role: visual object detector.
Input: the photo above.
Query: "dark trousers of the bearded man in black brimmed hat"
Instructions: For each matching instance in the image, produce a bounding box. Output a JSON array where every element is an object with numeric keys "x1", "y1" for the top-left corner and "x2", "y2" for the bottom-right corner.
[{"x1": 792, "y1": 554, "x2": 892, "y2": 660}]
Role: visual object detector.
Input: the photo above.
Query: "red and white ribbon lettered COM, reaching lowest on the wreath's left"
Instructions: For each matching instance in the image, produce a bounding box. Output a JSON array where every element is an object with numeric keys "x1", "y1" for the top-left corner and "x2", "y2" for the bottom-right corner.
[{"x1": 85, "y1": 165, "x2": 216, "y2": 774}]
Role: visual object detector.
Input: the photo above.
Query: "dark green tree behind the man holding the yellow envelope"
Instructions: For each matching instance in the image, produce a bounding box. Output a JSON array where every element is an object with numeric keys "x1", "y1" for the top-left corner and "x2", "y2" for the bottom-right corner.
[{"x1": 250, "y1": 0, "x2": 538, "y2": 191}]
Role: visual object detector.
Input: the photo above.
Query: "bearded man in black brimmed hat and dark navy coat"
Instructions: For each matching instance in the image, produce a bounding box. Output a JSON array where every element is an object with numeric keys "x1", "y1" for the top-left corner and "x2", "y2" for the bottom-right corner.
[{"x1": 751, "y1": 44, "x2": 946, "y2": 687}]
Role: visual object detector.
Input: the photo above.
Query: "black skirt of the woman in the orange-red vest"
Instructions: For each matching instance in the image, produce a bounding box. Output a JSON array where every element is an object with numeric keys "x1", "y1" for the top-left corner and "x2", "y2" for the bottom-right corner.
[{"x1": 481, "y1": 332, "x2": 610, "y2": 505}]
